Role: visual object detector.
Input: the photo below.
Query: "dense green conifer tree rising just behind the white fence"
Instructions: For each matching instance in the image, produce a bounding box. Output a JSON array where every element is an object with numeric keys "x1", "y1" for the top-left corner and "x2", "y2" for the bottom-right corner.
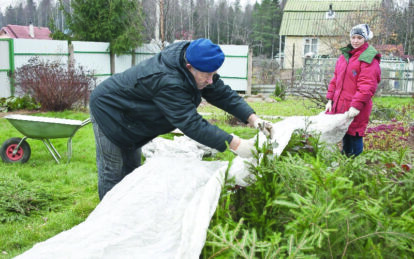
[{"x1": 60, "y1": 0, "x2": 142, "y2": 55}]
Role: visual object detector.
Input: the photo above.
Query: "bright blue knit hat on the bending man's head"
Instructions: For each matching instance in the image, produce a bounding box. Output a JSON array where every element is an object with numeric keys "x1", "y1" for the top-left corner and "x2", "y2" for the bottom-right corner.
[{"x1": 185, "y1": 38, "x2": 224, "y2": 73}]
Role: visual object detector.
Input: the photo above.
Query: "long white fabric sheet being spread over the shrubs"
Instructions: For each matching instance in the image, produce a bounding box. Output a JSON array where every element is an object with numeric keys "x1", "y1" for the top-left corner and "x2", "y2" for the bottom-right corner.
[{"x1": 16, "y1": 114, "x2": 352, "y2": 259}]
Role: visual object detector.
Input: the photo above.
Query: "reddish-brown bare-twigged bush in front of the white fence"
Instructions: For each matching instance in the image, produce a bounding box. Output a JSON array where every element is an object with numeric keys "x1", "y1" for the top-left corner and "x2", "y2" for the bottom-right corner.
[{"x1": 15, "y1": 57, "x2": 93, "y2": 111}]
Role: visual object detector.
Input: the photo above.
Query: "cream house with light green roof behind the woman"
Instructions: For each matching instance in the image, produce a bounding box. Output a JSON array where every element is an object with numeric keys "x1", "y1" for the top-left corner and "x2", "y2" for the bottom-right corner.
[{"x1": 279, "y1": 0, "x2": 382, "y2": 69}]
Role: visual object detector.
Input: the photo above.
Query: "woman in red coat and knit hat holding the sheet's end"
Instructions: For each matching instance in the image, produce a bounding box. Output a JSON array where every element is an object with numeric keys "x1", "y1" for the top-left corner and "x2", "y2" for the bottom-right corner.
[{"x1": 325, "y1": 24, "x2": 381, "y2": 156}]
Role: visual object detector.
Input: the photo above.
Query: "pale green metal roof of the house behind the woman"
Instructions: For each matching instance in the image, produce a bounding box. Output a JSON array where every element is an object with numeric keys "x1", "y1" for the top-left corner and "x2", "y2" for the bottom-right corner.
[{"x1": 279, "y1": 0, "x2": 381, "y2": 36}]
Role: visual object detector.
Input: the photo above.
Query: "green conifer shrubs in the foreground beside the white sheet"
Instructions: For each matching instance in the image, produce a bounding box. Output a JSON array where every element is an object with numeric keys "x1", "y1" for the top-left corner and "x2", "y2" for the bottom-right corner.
[{"x1": 200, "y1": 131, "x2": 414, "y2": 259}]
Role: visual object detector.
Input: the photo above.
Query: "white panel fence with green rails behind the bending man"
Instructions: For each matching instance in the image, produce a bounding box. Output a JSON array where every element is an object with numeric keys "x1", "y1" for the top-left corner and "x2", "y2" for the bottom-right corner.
[{"x1": 0, "y1": 39, "x2": 250, "y2": 97}]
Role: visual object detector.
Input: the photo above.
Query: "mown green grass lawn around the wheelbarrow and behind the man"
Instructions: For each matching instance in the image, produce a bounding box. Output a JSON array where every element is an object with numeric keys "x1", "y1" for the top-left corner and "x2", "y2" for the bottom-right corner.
[{"x1": 0, "y1": 98, "x2": 413, "y2": 258}]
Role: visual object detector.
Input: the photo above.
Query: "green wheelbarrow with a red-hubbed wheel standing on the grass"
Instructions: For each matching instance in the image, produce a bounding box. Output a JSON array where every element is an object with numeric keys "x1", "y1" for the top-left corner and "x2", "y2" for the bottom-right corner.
[{"x1": 0, "y1": 114, "x2": 91, "y2": 163}]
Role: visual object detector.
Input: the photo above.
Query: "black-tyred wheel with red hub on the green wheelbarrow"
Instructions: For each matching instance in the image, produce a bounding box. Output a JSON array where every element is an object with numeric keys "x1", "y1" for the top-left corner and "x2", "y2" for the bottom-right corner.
[{"x1": 0, "y1": 138, "x2": 31, "y2": 163}]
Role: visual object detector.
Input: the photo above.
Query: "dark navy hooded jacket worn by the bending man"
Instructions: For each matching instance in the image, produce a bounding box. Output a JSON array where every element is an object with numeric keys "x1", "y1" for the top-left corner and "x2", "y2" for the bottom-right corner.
[{"x1": 90, "y1": 42, "x2": 254, "y2": 151}]
